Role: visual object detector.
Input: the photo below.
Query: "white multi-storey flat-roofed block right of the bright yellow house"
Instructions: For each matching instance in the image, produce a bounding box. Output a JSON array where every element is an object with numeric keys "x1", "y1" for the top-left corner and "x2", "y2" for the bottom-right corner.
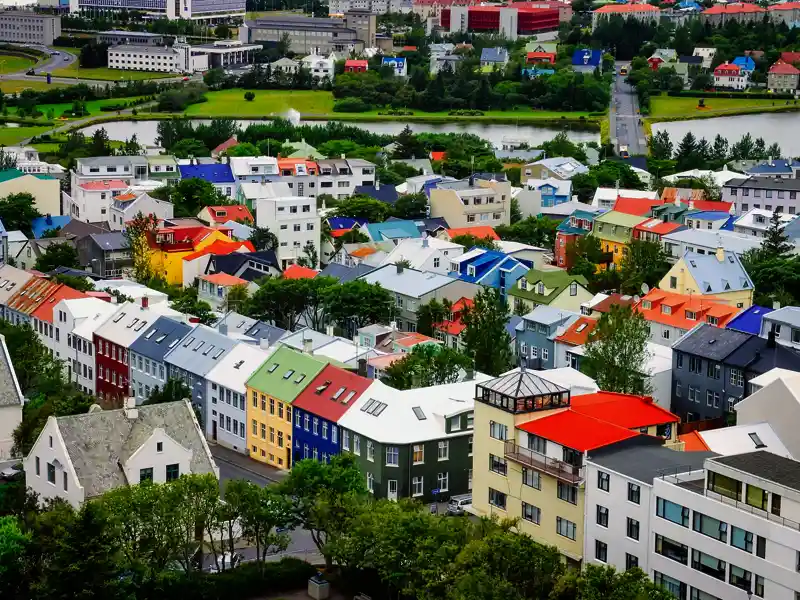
[{"x1": 256, "y1": 196, "x2": 321, "y2": 269}]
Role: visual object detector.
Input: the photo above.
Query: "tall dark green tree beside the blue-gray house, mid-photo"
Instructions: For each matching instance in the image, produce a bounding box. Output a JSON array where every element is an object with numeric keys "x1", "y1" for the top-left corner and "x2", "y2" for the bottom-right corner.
[{"x1": 461, "y1": 288, "x2": 512, "y2": 375}]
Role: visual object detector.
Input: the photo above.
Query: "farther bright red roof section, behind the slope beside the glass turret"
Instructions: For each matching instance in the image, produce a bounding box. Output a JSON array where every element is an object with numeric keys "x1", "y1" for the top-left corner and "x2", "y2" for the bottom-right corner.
[{"x1": 570, "y1": 392, "x2": 680, "y2": 429}]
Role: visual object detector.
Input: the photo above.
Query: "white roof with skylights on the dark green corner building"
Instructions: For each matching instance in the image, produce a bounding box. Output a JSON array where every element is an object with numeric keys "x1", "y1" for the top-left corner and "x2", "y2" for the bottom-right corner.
[{"x1": 339, "y1": 373, "x2": 491, "y2": 446}]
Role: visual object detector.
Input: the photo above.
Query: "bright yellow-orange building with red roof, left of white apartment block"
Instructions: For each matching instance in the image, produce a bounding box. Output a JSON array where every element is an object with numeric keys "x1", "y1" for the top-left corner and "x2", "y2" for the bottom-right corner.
[{"x1": 148, "y1": 225, "x2": 232, "y2": 286}]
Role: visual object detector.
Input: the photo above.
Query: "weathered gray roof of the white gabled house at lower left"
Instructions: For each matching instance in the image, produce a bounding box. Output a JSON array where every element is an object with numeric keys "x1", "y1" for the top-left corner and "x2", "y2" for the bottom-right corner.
[{"x1": 55, "y1": 400, "x2": 216, "y2": 498}]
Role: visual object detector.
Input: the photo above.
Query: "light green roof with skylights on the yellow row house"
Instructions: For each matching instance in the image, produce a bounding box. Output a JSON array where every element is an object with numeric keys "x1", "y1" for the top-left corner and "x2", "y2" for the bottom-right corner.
[{"x1": 247, "y1": 346, "x2": 329, "y2": 404}]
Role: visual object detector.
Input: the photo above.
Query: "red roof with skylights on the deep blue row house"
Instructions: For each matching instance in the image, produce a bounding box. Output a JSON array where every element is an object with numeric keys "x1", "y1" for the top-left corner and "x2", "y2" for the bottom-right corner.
[{"x1": 292, "y1": 365, "x2": 374, "y2": 423}]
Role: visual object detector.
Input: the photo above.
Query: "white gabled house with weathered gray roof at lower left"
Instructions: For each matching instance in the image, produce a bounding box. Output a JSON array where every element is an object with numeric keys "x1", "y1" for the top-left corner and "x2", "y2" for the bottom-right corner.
[{"x1": 23, "y1": 400, "x2": 219, "y2": 508}]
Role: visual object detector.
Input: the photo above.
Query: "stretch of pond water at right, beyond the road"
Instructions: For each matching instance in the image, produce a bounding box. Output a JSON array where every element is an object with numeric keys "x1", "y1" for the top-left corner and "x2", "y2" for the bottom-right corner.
[{"x1": 653, "y1": 113, "x2": 800, "y2": 156}]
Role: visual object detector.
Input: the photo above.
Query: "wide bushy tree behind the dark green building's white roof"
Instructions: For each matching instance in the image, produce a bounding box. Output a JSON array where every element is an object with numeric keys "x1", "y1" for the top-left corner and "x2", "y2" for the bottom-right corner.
[{"x1": 383, "y1": 342, "x2": 472, "y2": 390}]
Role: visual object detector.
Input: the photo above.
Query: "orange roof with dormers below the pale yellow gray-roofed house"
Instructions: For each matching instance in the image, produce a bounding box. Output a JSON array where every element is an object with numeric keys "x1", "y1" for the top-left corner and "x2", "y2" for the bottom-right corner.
[{"x1": 635, "y1": 289, "x2": 740, "y2": 331}]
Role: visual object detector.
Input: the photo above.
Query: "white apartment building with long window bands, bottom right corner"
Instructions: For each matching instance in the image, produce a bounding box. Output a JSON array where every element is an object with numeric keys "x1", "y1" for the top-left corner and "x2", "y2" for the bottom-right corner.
[{"x1": 649, "y1": 450, "x2": 800, "y2": 600}]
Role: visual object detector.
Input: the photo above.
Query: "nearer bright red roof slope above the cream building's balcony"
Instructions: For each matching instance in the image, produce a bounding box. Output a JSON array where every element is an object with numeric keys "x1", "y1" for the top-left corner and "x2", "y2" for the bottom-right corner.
[{"x1": 519, "y1": 410, "x2": 640, "y2": 452}]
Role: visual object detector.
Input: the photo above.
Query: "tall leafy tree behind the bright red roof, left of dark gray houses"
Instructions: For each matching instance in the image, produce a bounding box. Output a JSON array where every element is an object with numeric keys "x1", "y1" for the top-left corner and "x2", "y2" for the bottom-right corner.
[{"x1": 583, "y1": 306, "x2": 650, "y2": 395}]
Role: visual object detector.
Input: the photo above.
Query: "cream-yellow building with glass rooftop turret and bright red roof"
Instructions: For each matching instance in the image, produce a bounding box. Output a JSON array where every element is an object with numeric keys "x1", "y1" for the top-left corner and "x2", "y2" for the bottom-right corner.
[{"x1": 472, "y1": 370, "x2": 679, "y2": 566}]
